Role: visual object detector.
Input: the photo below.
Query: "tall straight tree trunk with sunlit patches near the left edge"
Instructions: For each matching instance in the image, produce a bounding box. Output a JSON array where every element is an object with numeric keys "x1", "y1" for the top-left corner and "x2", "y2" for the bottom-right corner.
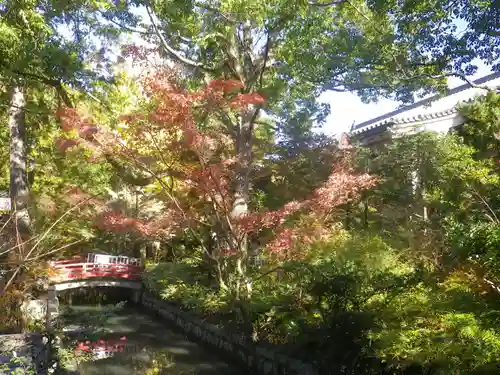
[{"x1": 8, "y1": 86, "x2": 31, "y2": 235}]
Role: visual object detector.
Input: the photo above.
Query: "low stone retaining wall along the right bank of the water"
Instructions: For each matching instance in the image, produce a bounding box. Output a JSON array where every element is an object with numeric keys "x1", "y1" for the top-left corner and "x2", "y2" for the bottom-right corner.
[{"x1": 142, "y1": 293, "x2": 317, "y2": 375}]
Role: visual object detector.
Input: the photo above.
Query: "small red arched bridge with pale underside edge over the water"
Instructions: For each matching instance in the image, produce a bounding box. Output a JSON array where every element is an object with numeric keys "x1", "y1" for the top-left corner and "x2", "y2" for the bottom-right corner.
[{"x1": 49, "y1": 253, "x2": 144, "y2": 290}]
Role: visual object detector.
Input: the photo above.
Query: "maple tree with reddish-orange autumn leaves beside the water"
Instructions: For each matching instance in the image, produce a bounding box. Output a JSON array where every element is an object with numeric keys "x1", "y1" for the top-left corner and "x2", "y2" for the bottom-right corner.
[{"x1": 54, "y1": 71, "x2": 376, "y2": 296}]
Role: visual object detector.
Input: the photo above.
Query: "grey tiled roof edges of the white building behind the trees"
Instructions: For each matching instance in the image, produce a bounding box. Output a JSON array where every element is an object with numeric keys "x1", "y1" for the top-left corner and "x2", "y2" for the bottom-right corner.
[{"x1": 350, "y1": 72, "x2": 500, "y2": 135}]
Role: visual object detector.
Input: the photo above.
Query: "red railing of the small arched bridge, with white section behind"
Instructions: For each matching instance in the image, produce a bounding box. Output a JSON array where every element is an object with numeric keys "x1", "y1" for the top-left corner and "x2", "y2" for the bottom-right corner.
[{"x1": 49, "y1": 254, "x2": 143, "y2": 283}]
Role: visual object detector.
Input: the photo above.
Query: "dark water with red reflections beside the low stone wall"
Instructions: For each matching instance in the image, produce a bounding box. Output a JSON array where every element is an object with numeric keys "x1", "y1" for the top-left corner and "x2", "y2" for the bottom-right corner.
[{"x1": 58, "y1": 306, "x2": 243, "y2": 375}]
